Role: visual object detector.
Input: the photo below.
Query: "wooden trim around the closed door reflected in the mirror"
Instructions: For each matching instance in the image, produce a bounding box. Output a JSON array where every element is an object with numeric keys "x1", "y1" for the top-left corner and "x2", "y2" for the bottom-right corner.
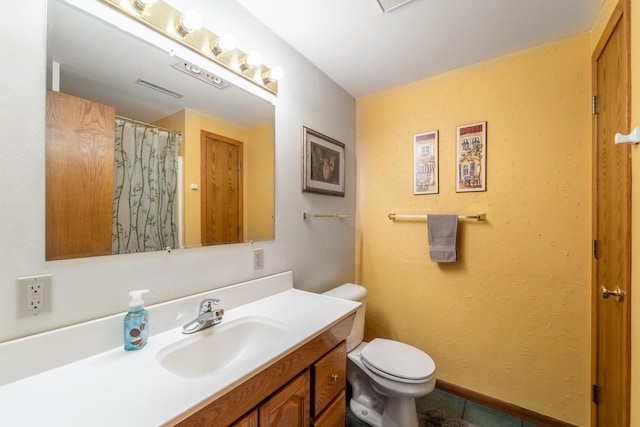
[{"x1": 200, "y1": 130, "x2": 244, "y2": 246}]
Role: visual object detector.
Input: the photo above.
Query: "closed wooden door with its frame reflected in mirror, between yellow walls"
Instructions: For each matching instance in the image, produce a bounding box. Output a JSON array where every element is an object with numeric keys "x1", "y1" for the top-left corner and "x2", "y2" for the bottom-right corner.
[{"x1": 200, "y1": 131, "x2": 242, "y2": 246}]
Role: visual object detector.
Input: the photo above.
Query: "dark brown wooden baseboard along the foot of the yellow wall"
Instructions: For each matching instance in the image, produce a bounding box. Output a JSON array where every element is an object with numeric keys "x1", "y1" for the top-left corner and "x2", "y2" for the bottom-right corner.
[{"x1": 436, "y1": 379, "x2": 577, "y2": 427}]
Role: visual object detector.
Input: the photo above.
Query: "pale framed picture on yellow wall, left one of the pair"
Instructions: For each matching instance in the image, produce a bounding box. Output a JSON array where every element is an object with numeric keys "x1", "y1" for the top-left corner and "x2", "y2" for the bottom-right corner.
[{"x1": 413, "y1": 130, "x2": 438, "y2": 194}]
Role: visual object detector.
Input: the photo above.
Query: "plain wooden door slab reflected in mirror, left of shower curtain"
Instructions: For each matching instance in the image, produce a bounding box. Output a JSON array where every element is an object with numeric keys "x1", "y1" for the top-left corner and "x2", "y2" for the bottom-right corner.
[{"x1": 45, "y1": 92, "x2": 116, "y2": 260}]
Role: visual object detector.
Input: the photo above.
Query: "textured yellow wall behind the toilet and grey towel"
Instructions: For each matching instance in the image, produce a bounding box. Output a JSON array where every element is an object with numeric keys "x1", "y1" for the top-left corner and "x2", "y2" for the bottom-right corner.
[{"x1": 356, "y1": 34, "x2": 591, "y2": 426}]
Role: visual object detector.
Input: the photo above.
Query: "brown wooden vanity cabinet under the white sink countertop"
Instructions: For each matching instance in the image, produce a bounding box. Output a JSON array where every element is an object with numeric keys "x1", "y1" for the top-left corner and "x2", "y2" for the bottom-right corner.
[{"x1": 175, "y1": 314, "x2": 355, "y2": 427}]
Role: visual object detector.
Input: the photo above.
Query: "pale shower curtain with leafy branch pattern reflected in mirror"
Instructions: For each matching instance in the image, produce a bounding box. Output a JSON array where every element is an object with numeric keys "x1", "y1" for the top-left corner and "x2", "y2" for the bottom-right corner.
[{"x1": 112, "y1": 119, "x2": 181, "y2": 254}]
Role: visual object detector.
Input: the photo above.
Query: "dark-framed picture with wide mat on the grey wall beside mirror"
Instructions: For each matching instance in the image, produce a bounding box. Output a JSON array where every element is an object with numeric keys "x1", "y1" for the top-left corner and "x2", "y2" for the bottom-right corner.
[{"x1": 302, "y1": 126, "x2": 345, "y2": 197}]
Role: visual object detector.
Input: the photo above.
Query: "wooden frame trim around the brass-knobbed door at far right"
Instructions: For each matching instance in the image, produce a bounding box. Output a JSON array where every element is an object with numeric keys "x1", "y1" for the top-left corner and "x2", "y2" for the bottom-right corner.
[{"x1": 591, "y1": 0, "x2": 632, "y2": 427}]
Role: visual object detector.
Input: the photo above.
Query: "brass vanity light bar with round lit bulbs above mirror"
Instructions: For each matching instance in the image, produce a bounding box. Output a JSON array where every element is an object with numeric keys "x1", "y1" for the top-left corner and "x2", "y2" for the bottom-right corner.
[{"x1": 99, "y1": 0, "x2": 283, "y2": 95}]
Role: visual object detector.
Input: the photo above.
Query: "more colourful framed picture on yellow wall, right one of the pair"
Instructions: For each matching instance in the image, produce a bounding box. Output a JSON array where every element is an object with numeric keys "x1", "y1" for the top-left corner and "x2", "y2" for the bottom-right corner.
[{"x1": 456, "y1": 122, "x2": 487, "y2": 193}]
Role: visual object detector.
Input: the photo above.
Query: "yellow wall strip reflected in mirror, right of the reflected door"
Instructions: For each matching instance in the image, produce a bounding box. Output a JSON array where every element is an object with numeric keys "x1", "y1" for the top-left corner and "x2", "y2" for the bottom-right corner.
[{"x1": 243, "y1": 125, "x2": 275, "y2": 241}]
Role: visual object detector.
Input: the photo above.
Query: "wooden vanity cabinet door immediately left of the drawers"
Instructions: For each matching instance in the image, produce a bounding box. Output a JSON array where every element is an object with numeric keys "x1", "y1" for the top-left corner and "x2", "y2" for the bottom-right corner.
[{"x1": 259, "y1": 370, "x2": 310, "y2": 427}]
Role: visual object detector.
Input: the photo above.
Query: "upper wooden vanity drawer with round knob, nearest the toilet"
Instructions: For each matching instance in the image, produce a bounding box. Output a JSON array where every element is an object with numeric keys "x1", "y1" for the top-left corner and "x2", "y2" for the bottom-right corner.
[{"x1": 312, "y1": 342, "x2": 347, "y2": 417}]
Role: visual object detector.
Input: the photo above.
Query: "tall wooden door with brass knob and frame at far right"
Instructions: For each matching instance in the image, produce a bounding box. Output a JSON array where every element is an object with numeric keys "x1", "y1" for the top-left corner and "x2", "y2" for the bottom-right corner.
[{"x1": 592, "y1": 1, "x2": 631, "y2": 427}]
